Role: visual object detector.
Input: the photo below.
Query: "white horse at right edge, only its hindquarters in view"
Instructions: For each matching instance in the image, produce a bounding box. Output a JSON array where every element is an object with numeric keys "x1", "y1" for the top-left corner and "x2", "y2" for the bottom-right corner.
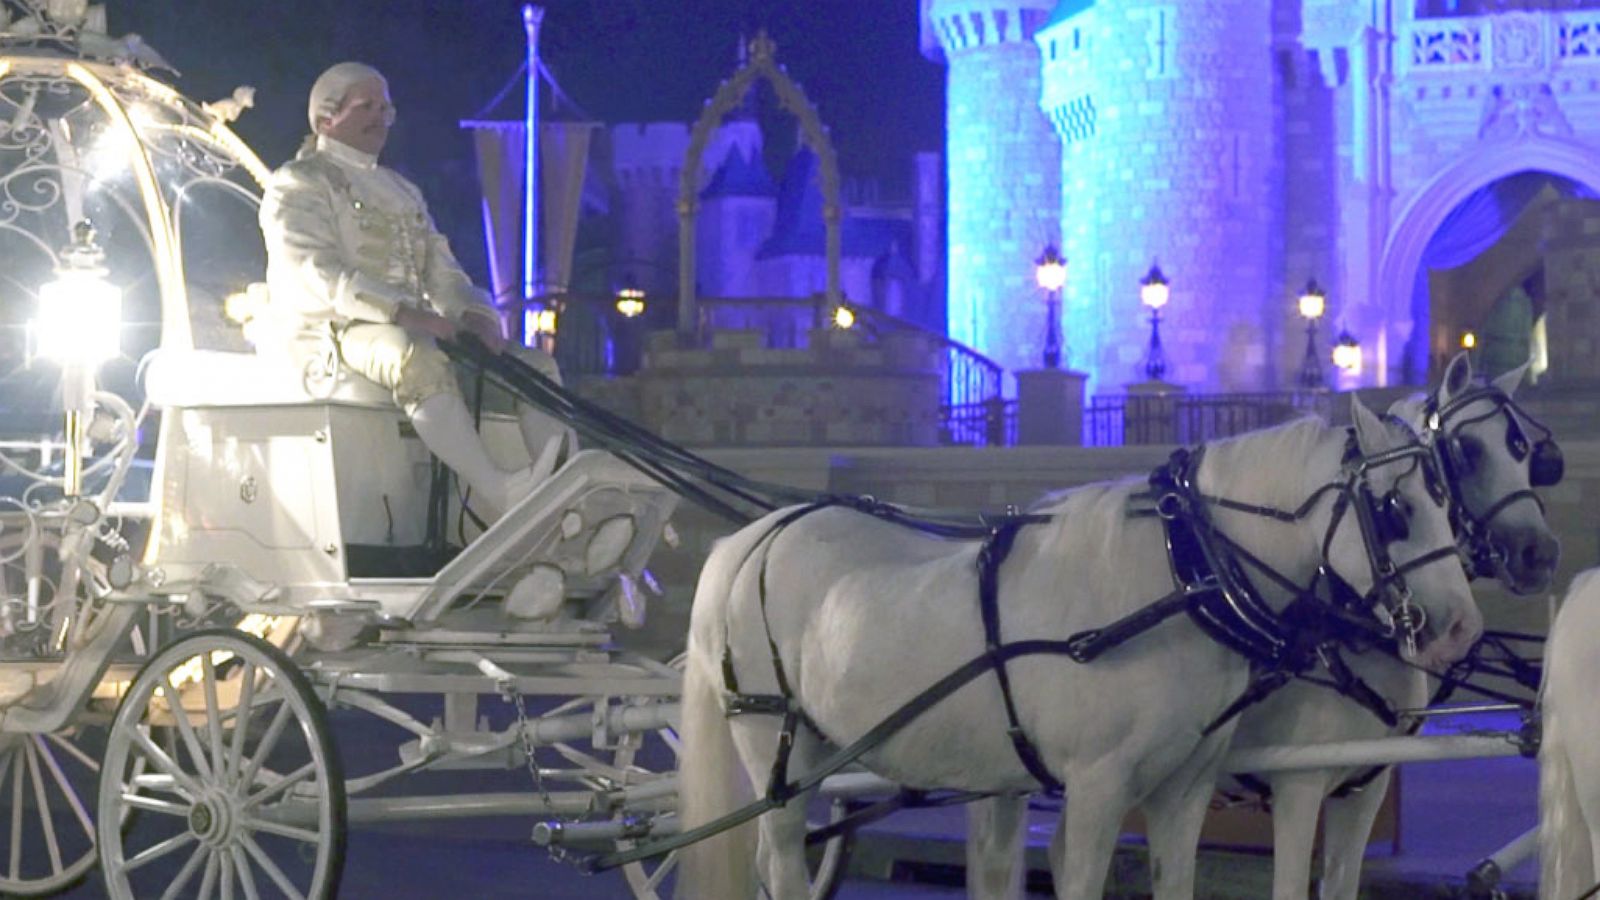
[{"x1": 1539, "y1": 569, "x2": 1600, "y2": 900}]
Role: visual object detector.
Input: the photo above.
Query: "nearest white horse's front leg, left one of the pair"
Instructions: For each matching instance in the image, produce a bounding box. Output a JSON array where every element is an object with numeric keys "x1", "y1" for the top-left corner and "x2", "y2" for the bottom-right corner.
[{"x1": 1050, "y1": 767, "x2": 1133, "y2": 900}]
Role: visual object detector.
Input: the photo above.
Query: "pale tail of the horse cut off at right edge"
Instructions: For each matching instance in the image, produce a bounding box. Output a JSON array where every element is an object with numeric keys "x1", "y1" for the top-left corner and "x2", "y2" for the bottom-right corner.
[{"x1": 1539, "y1": 570, "x2": 1600, "y2": 900}]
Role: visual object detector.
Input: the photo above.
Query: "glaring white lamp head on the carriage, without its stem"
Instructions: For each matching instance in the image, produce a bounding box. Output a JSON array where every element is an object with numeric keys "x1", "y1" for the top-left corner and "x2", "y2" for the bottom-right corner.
[{"x1": 34, "y1": 221, "x2": 122, "y2": 370}]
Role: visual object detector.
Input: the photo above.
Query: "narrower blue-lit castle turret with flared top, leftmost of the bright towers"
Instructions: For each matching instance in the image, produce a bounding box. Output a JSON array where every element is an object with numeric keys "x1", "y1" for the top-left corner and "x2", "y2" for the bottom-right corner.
[{"x1": 922, "y1": 0, "x2": 1077, "y2": 381}]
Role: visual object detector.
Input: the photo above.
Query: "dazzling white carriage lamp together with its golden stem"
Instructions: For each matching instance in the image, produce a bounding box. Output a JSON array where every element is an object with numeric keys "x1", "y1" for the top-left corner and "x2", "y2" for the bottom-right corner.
[{"x1": 34, "y1": 221, "x2": 122, "y2": 496}]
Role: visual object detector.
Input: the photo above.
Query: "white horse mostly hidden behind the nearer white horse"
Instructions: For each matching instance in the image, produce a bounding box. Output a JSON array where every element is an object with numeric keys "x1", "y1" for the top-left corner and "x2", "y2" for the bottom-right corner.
[{"x1": 966, "y1": 354, "x2": 1558, "y2": 900}]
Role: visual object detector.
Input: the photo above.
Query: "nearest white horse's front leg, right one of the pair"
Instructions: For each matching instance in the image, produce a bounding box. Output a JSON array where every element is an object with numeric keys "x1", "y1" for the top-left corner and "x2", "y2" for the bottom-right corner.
[{"x1": 1141, "y1": 738, "x2": 1227, "y2": 900}]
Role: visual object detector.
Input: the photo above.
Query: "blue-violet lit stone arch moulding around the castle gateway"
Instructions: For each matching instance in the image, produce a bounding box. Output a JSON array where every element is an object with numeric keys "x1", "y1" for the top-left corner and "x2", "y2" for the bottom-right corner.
[{"x1": 1378, "y1": 135, "x2": 1600, "y2": 379}]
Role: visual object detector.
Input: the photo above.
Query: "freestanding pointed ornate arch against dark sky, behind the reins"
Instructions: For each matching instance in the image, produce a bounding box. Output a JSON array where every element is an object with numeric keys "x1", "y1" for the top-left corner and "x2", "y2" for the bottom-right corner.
[{"x1": 677, "y1": 30, "x2": 843, "y2": 336}]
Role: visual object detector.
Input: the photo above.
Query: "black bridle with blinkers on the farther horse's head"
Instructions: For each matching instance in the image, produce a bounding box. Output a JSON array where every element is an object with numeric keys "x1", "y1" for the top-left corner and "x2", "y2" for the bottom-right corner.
[{"x1": 1422, "y1": 386, "x2": 1566, "y2": 577}]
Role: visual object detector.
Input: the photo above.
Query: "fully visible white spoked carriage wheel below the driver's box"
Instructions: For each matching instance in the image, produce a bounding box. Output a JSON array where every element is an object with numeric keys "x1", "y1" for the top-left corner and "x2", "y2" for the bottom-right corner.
[{"x1": 99, "y1": 631, "x2": 346, "y2": 900}]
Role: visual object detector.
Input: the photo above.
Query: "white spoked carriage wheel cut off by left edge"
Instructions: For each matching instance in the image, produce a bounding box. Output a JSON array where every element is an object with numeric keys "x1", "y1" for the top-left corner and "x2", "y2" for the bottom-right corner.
[{"x1": 0, "y1": 722, "x2": 106, "y2": 897}]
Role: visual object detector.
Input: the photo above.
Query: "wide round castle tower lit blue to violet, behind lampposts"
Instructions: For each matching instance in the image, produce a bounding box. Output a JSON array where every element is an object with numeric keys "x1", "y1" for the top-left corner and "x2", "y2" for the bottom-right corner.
[{"x1": 1036, "y1": 0, "x2": 1291, "y2": 389}]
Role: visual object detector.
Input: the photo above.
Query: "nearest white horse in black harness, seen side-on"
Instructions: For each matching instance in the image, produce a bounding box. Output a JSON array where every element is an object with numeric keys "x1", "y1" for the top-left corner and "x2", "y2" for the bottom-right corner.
[{"x1": 678, "y1": 395, "x2": 1482, "y2": 900}]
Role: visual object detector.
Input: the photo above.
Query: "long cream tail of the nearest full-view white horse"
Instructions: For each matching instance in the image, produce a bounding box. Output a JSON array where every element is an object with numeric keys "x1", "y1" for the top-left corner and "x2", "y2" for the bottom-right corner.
[{"x1": 674, "y1": 533, "x2": 757, "y2": 900}]
